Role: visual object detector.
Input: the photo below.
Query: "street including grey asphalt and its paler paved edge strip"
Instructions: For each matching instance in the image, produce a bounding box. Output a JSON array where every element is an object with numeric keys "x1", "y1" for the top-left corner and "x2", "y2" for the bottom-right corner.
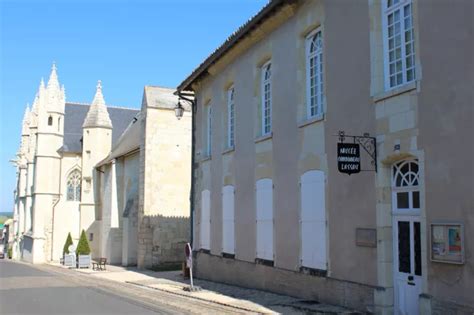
[{"x1": 0, "y1": 260, "x2": 256, "y2": 314}]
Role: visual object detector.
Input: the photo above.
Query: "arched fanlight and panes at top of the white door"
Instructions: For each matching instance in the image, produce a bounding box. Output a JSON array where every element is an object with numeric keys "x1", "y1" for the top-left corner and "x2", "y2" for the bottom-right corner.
[{"x1": 392, "y1": 160, "x2": 420, "y2": 210}]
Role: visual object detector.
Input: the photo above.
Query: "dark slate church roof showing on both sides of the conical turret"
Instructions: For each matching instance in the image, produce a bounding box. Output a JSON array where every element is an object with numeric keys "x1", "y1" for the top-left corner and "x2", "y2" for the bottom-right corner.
[{"x1": 61, "y1": 103, "x2": 139, "y2": 153}]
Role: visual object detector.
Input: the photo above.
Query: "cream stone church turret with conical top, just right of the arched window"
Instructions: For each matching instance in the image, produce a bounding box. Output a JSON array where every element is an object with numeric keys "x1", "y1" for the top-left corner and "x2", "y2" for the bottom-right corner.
[{"x1": 81, "y1": 81, "x2": 112, "y2": 239}]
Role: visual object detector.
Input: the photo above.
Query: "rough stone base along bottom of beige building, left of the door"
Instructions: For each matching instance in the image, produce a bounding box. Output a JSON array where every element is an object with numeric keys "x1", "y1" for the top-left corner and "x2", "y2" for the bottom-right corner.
[{"x1": 193, "y1": 252, "x2": 383, "y2": 312}]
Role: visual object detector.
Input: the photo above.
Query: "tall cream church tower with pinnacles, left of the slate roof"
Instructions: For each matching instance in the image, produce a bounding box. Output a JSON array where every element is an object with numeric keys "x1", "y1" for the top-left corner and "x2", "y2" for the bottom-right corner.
[{"x1": 27, "y1": 63, "x2": 65, "y2": 263}]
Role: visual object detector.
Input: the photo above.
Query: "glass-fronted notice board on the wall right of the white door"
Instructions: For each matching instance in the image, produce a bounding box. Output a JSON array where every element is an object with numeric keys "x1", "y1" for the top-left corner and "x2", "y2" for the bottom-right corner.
[{"x1": 431, "y1": 223, "x2": 464, "y2": 264}]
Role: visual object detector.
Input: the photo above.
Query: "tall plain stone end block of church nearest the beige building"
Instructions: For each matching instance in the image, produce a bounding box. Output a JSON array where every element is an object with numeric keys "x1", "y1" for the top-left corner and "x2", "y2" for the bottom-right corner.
[{"x1": 138, "y1": 86, "x2": 191, "y2": 268}]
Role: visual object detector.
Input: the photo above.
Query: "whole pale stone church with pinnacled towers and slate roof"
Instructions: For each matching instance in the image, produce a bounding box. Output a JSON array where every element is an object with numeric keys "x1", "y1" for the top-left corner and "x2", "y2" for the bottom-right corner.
[{"x1": 13, "y1": 65, "x2": 190, "y2": 267}]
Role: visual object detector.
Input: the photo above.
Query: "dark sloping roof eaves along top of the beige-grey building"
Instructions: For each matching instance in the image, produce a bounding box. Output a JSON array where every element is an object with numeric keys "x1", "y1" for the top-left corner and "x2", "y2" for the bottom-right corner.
[{"x1": 177, "y1": 0, "x2": 297, "y2": 92}]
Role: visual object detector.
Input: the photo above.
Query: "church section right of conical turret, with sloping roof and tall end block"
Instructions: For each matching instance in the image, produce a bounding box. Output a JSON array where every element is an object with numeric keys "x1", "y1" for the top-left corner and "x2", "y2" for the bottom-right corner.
[{"x1": 97, "y1": 86, "x2": 191, "y2": 268}]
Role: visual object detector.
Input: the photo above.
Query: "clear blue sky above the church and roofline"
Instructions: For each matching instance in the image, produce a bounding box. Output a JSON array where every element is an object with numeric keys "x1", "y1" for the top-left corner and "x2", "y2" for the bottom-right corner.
[{"x1": 0, "y1": 0, "x2": 267, "y2": 212}]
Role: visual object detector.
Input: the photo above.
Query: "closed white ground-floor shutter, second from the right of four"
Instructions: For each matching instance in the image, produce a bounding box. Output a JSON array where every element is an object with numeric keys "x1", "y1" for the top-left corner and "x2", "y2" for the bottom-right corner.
[{"x1": 257, "y1": 179, "x2": 273, "y2": 260}]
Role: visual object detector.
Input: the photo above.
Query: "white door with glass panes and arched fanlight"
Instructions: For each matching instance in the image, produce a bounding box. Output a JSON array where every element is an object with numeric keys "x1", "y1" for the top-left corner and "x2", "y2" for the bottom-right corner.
[{"x1": 392, "y1": 160, "x2": 422, "y2": 315}]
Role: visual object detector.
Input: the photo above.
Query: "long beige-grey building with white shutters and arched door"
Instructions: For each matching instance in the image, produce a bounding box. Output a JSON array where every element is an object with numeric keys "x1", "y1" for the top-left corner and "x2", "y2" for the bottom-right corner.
[{"x1": 177, "y1": 0, "x2": 474, "y2": 314}]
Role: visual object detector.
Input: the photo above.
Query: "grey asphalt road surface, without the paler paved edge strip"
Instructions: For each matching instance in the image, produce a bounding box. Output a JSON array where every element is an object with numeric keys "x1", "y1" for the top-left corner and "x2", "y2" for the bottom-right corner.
[{"x1": 0, "y1": 259, "x2": 176, "y2": 314}]
